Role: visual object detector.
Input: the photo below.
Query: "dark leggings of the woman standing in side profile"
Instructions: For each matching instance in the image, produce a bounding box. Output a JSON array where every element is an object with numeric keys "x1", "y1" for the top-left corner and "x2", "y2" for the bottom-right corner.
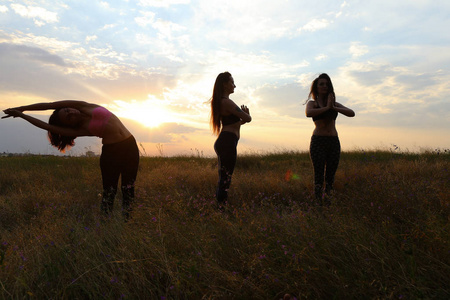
[{"x1": 214, "y1": 131, "x2": 238, "y2": 204}]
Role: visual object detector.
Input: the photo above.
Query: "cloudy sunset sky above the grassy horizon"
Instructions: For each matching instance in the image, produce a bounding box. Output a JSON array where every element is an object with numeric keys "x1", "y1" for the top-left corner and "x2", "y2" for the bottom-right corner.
[{"x1": 0, "y1": 0, "x2": 450, "y2": 156}]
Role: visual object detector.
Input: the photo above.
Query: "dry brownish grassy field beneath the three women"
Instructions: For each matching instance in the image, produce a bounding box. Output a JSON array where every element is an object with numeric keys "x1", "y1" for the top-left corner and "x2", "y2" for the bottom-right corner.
[{"x1": 0, "y1": 151, "x2": 450, "y2": 300}]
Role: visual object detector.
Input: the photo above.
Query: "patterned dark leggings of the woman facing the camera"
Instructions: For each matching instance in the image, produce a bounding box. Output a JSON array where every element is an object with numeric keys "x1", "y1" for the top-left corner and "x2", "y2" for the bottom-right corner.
[{"x1": 309, "y1": 135, "x2": 341, "y2": 199}]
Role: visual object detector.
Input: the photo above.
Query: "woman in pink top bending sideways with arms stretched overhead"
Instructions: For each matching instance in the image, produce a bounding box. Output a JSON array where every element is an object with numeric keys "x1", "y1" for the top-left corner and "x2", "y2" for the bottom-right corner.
[{"x1": 3, "y1": 100, "x2": 139, "y2": 218}]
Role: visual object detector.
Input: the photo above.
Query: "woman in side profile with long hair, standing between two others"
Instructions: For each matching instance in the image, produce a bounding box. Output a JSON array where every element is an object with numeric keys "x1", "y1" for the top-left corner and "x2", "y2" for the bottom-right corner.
[{"x1": 210, "y1": 72, "x2": 252, "y2": 206}]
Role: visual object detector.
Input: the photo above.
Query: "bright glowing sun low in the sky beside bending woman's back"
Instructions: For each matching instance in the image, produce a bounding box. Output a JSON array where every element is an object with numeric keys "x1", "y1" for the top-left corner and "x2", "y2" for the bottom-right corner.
[{"x1": 110, "y1": 98, "x2": 175, "y2": 128}]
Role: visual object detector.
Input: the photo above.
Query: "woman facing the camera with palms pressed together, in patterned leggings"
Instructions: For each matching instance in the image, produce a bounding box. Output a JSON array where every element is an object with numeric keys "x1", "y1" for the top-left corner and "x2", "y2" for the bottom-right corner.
[{"x1": 306, "y1": 73, "x2": 355, "y2": 205}]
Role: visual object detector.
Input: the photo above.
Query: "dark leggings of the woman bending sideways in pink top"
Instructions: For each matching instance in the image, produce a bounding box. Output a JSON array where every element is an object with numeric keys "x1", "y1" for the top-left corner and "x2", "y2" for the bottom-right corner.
[{"x1": 100, "y1": 136, "x2": 139, "y2": 216}]
